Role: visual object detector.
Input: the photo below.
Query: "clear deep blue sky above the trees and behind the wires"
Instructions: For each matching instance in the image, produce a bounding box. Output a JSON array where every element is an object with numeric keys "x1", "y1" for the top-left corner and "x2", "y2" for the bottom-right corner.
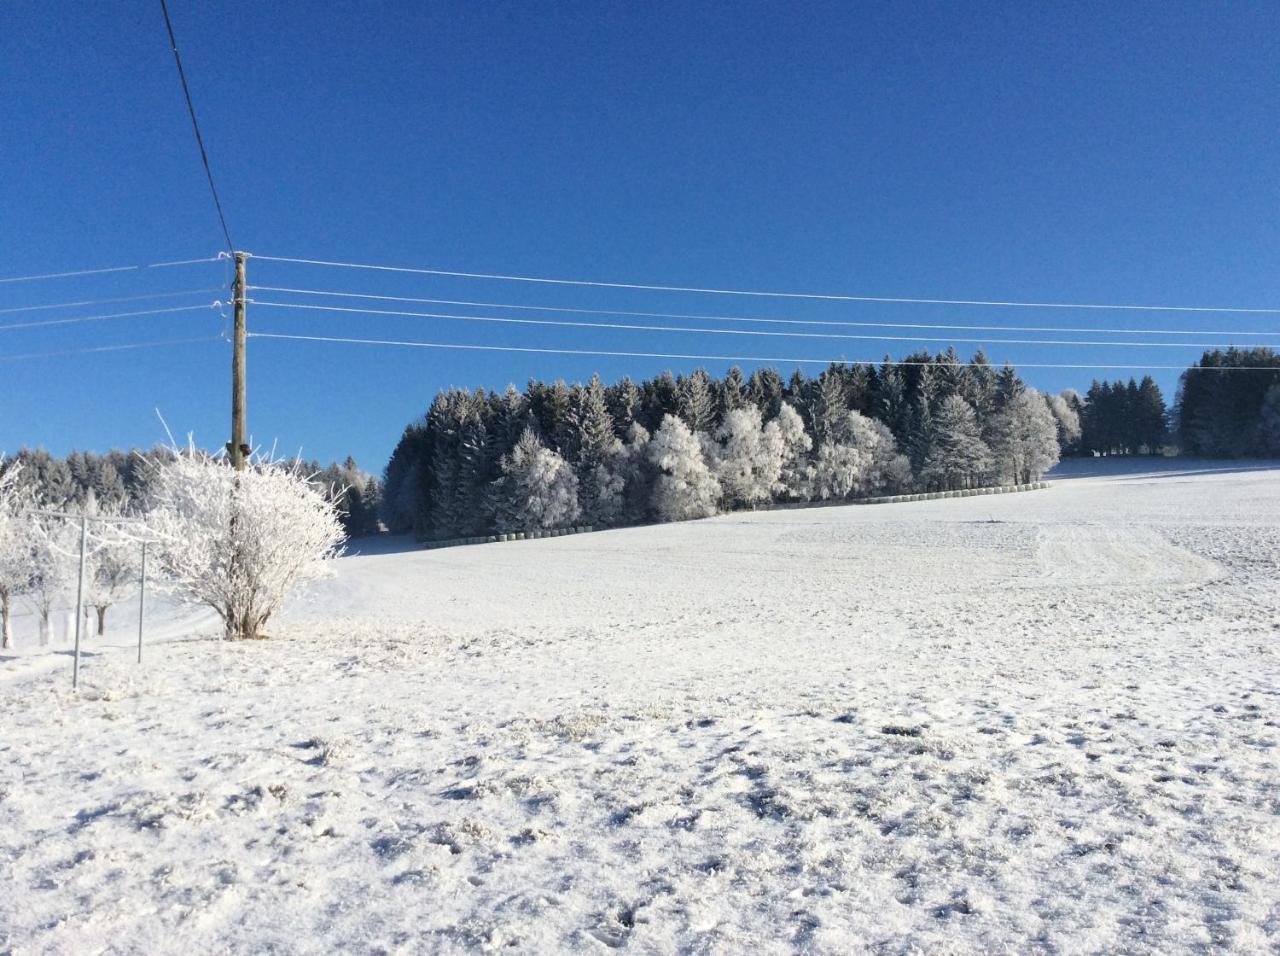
[{"x1": 0, "y1": 0, "x2": 1280, "y2": 471}]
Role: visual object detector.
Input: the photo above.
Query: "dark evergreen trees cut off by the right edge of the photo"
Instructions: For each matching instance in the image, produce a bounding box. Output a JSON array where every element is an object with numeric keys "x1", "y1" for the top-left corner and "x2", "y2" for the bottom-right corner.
[{"x1": 1175, "y1": 348, "x2": 1280, "y2": 458}]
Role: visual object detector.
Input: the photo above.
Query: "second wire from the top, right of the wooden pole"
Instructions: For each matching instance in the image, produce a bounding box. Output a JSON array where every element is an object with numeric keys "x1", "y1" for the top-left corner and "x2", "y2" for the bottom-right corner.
[{"x1": 250, "y1": 285, "x2": 1280, "y2": 337}]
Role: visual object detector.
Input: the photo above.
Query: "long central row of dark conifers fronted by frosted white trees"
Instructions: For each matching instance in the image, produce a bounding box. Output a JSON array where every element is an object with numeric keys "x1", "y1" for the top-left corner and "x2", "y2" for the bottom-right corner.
[{"x1": 383, "y1": 351, "x2": 1080, "y2": 538}]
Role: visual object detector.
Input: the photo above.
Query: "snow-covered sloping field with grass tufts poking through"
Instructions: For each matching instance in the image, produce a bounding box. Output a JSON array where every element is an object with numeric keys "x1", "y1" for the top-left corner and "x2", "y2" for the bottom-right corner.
[{"x1": 0, "y1": 461, "x2": 1280, "y2": 953}]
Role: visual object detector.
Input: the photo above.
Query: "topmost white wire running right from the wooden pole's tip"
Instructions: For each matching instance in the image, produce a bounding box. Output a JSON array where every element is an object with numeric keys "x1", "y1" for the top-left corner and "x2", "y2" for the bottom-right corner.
[{"x1": 255, "y1": 255, "x2": 1280, "y2": 315}]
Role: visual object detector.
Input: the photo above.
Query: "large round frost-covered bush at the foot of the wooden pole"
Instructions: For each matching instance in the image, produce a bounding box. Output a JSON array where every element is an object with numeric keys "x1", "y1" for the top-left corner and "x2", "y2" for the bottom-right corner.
[{"x1": 147, "y1": 448, "x2": 343, "y2": 640}]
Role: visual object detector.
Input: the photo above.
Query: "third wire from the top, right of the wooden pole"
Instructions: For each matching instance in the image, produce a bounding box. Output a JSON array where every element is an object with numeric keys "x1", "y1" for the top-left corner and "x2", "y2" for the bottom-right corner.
[{"x1": 250, "y1": 298, "x2": 1269, "y2": 349}]
